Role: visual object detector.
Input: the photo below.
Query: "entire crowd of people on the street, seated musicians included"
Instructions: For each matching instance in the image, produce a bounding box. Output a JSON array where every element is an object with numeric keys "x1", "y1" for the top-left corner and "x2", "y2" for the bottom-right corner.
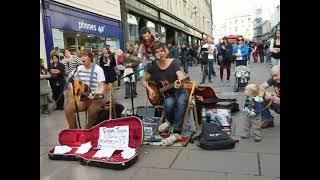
[{"x1": 40, "y1": 27, "x2": 280, "y2": 145}]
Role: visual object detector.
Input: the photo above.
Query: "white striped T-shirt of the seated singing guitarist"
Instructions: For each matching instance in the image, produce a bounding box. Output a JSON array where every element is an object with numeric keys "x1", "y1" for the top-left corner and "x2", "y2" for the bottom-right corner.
[{"x1": 74, "y1": 64, "x2": 105, "y2": 92}]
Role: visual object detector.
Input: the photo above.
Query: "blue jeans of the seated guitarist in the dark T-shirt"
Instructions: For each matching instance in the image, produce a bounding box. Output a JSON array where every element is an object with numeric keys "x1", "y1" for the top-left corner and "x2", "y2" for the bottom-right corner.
[{"x1": 164, "y1": 89, "x2": 189, "y2": 133}]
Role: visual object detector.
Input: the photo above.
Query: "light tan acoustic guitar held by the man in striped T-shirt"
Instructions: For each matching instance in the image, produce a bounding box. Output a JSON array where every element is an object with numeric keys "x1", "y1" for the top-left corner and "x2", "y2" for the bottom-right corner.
[{"x1": 68, "y1": 80, "x2": 104, "y2": 101}]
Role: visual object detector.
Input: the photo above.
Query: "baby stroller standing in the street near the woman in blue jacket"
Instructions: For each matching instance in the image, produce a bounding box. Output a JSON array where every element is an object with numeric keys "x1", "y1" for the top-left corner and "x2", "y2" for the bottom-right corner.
[{"x1": 233, "y1": 66, "x2": 250, "y2": 92}]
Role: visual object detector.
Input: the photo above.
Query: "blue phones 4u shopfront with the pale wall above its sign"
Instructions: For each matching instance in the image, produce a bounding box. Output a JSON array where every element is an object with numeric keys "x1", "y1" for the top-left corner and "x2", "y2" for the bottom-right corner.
[{"x1": 42, "y1": 0, "x2": 124, "y2": 62}]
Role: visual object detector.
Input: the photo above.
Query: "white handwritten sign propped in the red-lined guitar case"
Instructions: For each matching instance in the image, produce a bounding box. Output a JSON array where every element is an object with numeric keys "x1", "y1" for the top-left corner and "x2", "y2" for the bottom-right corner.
[{"x1": 97, "y1": 126, "x2": 129, "y2": 149}]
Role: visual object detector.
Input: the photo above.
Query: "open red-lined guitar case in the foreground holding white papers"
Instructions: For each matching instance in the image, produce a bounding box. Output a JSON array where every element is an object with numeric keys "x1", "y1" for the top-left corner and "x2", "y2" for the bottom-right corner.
[{"x1": 48, "y1": 116, "x2": 143, "y2": 169}]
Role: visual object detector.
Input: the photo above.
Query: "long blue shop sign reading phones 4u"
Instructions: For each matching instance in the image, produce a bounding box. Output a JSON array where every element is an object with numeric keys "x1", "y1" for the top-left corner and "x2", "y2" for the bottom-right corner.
[{"x1": 48, "y1": 11, "x2": 121, "y2": 38}]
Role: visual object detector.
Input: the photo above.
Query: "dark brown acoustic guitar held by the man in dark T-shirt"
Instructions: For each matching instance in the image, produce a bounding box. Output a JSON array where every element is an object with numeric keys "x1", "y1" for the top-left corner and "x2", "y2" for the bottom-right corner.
[{"x1": 147, "y1": 76, "x2": 190, "y2": 106}]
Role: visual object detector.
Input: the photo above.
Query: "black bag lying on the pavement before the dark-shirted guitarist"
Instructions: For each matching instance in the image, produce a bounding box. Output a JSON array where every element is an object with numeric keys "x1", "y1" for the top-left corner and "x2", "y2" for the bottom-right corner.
[{"x1": 198, "y1": 122, "x2": 239, "y2": 150}]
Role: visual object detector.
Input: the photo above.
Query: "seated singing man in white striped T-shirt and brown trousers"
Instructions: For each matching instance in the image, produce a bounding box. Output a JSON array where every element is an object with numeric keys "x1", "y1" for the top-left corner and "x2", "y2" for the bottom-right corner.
[{"x1": 64, "y1": 49, "x2": 105, "y2": 129}]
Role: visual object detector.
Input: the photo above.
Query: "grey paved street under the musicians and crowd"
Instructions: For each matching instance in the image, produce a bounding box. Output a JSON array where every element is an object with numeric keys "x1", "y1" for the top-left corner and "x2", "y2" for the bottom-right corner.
[{"x1": 40, "y1": 63, "x2": 280, "y2": 180}]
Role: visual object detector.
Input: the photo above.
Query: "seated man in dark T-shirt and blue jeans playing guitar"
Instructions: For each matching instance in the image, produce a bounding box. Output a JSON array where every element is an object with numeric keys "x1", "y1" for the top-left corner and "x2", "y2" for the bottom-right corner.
[{"x1": 142, "y1": 41, "x2": 189, "y2": 145}]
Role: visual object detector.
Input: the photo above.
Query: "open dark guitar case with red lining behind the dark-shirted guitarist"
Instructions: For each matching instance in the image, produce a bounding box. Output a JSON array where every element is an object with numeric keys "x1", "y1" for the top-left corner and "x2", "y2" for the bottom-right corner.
[{"x1": 195, "y1": 86, "x2": 239, "y2": 119}]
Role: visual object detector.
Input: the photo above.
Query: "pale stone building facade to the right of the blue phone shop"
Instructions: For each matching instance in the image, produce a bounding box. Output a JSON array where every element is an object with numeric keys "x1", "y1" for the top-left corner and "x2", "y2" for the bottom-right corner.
[{"x1": 120, "y1": 0, "x2": 212, "y2": 45}]
